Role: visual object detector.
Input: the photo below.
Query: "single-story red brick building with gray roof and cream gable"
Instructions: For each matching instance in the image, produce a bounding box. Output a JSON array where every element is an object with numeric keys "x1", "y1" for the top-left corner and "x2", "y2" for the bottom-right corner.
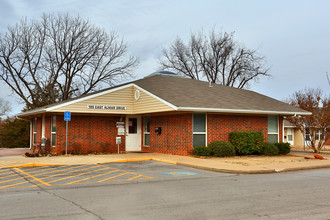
[{"x1": 18, "y1": 71, "x2": 309, "y2": 155}]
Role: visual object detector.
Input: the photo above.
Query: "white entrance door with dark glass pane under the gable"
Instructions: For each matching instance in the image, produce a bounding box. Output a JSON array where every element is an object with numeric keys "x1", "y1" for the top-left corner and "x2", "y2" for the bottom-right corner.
[{"x1": 126, "y1": 116, "x2": 141, "y2": 151}]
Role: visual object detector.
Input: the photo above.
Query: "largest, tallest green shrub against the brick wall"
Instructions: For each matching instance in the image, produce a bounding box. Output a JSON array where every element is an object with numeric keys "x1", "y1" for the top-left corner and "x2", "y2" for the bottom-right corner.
[{"x1": 229, "y1": 131, "x2": 265, "y2": 155}]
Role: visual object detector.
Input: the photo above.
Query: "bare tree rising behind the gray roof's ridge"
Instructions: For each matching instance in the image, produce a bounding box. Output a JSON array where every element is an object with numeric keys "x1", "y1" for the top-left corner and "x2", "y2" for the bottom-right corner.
[{"x1": 160, "y1": 31, "x2": 269, "y2": 88}]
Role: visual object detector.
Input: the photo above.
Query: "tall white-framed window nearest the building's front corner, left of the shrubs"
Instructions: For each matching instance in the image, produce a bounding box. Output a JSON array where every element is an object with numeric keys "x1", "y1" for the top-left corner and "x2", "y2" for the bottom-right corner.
[{"x1": 193, "y1": 113, "x2": 206, "y2": 147}]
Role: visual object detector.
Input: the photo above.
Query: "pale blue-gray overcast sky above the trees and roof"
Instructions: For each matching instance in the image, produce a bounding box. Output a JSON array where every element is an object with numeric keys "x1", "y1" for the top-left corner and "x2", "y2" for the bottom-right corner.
[{"x1": 0, "y1": 0, "x2": 330, "y2": 114}]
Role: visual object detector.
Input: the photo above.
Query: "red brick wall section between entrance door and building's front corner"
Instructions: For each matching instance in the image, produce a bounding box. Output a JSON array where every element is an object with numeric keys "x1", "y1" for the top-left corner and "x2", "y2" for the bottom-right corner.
[{"x1": 142, "y1": 114, "x2": 193, "y2": 155}]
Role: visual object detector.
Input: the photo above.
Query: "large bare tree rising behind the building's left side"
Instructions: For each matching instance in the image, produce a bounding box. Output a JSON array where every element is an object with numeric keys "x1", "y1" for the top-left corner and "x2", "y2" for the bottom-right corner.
[{"x1": 0, "y1": 14, "x2": 138, "y2": 109}]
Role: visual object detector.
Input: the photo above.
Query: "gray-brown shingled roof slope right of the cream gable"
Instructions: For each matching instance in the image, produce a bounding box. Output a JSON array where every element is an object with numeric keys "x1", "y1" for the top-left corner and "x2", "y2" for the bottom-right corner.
[{"x1": 134, "y1": 75, "x2": 307, "y2": 113}]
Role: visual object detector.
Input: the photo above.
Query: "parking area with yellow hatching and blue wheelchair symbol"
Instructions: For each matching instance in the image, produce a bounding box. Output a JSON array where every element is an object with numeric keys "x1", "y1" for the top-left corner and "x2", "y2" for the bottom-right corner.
[{"x1": 0, "y1": 161, "x2": 232, "y2": 190}]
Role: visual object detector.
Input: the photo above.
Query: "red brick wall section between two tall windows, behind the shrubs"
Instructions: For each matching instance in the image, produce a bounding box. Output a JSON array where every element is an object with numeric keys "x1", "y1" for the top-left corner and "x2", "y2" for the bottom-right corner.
[{"x1": 207, "y1": 114, "x2": 268, "y2": 144}]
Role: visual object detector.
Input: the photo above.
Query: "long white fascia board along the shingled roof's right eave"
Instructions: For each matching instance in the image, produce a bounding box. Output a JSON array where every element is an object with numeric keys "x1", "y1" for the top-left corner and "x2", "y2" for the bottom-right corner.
[{"x1": 177, "y1": 107, "x2": 312, "y2": 115}]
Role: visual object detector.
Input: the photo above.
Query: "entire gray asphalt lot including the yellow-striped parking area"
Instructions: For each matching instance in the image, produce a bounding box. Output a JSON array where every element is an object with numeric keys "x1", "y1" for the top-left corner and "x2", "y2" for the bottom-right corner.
[{"x1": 0, "y1": 161, "x2": 330, "y2": 220}]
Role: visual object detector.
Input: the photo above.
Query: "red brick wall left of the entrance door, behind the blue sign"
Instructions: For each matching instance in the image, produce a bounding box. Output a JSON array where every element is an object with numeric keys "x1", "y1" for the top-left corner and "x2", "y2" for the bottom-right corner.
[{"x1": 55, "y1": 114, "x2": 125, "y2": 154}]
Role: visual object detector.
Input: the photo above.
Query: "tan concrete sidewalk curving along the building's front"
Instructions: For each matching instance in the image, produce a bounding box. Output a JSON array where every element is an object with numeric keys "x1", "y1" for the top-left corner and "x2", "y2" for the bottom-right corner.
[{"x1": 0, "y1": 152, "x2": 330, "y2": 173}]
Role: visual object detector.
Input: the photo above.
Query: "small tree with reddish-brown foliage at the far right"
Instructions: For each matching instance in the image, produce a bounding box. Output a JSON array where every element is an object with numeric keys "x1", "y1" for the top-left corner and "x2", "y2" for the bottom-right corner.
[{"x1": 288, "y1": 89, "x2": 330, "y2": 153}]
